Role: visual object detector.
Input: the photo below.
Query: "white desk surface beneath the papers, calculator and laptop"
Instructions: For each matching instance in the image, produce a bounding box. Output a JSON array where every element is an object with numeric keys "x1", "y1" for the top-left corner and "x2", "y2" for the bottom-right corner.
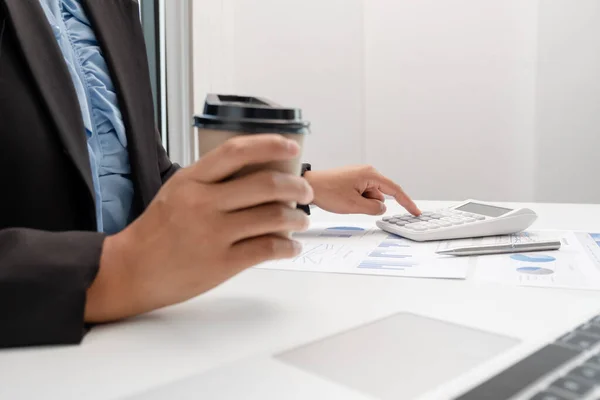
[{"x1": 0, "y1": 202, "x2": 600, "y2": 400}]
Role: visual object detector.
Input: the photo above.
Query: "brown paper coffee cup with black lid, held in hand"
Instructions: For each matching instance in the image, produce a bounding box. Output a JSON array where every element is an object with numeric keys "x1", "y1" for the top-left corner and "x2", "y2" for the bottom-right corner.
[{"x1": 194, "y1": 94, "x2": 310, "y2": 227}]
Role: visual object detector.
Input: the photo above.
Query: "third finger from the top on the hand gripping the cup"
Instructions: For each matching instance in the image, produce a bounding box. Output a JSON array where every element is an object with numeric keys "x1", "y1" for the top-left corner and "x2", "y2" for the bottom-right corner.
[{"x1": 224, "y1": 203, "x2": 309, "y2": 243}]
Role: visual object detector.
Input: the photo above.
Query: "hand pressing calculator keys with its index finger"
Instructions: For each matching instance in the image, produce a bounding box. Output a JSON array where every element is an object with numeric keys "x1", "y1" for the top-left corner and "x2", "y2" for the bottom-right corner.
[{"x1": 304, "y1": 166, "x2": 421, "y2": 216}]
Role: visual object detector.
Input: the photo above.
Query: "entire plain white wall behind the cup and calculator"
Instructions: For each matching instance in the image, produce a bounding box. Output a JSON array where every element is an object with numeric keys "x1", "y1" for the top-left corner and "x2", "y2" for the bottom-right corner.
[{"x1": 194, "y1": 0, "x2": 600, "y2": 202}]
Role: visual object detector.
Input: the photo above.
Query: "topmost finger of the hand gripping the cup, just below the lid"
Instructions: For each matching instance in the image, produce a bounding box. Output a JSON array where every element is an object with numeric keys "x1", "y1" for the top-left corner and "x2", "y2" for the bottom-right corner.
[{"x1": 186, "y1": 135, "x2": 300, "y2": 183}]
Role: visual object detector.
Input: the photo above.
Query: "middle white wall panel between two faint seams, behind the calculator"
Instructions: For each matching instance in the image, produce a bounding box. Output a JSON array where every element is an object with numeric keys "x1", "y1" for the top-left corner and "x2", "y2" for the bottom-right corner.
[{"x1": 365, "y1": 0, "x2": 537, "y2": 200}]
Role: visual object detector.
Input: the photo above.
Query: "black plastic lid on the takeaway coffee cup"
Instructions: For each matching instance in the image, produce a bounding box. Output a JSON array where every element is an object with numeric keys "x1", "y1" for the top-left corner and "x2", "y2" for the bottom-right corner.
[{"x1": 194, "y1": 94, "x2": 310, "y2": 134}]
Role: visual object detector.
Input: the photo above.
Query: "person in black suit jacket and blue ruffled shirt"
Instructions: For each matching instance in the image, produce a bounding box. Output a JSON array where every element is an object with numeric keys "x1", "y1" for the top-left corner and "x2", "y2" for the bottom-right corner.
[{"x1": 0, "y1": 0, "x2": 419, "y2": 347}]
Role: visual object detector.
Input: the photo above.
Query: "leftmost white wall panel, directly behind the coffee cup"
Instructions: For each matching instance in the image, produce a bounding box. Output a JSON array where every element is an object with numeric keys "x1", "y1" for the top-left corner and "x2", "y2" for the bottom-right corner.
[{"x1": 194, "y1": 0, "x2": 364, "y2": 168}]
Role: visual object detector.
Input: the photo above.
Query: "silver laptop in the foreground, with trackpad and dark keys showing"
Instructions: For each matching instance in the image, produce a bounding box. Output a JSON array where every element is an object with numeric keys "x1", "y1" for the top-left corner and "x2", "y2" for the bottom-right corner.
[{"x1": 123, "y1": 305, "x2": 600, "y2": 400}]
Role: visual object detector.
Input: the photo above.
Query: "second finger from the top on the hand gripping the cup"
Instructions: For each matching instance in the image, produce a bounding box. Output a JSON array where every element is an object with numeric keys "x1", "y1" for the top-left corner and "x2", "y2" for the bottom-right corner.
[{"x1": 216, "y1": 171, "x2": 314, "y2": 211}]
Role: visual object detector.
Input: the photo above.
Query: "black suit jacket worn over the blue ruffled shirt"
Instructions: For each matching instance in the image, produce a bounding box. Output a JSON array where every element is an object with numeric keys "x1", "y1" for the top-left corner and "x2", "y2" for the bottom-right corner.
[{"x1": 0, "y1": 0, "x2": 177, "y2": 347}]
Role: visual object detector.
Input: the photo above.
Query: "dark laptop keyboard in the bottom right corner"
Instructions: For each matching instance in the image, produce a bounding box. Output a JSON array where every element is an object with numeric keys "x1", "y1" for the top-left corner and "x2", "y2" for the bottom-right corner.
[{"x1": 456, "y1": 315, "x2": 600, "y2": 400}]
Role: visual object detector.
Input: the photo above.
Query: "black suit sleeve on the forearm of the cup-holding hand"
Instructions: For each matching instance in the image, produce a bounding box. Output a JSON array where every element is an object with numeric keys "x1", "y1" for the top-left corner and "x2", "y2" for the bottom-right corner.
[{"x1": 0, "y1": 228, "x2": 105, "y2": 348}]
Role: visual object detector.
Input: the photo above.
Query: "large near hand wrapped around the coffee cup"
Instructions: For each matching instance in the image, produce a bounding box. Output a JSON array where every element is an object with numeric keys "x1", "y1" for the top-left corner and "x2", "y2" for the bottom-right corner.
[{"x1": 85, "y1": 135, "x2": 313, "y2": 322}]
